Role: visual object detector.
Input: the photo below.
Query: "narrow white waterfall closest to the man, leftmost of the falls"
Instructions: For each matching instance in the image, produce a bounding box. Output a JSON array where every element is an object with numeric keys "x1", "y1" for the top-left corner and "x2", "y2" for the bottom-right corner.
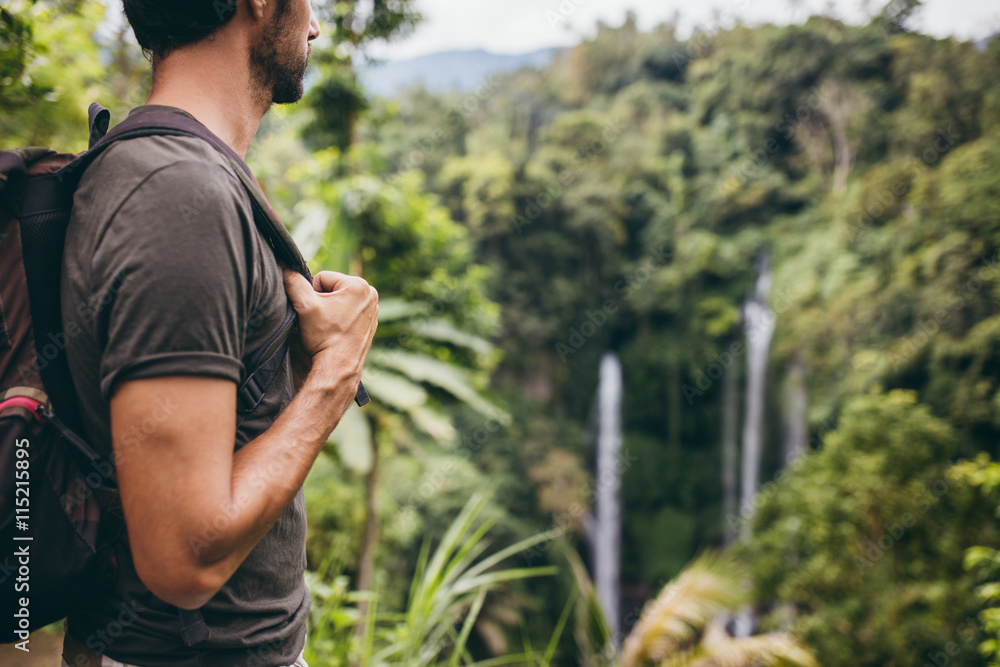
[{"x1": 592, "y1": 352, "x2": 622, "y2": 637}]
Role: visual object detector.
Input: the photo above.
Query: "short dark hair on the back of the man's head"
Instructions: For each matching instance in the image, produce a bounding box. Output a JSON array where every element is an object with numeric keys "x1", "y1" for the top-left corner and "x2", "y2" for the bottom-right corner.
[{"x1": 122, "y1": 0, "x2": 238, "y2": 55}]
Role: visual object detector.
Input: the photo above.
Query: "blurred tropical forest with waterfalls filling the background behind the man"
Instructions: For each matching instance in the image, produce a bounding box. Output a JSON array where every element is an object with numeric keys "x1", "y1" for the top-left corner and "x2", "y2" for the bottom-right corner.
[{"x1": 0, "y1": 0, "x2": 1000, "y2": 667}]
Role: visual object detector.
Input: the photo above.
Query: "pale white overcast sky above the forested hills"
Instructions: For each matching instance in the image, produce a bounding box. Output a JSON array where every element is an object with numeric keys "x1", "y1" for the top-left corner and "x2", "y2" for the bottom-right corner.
[{"x1": 372, "y1": 0, "x2": 1000, "y2": 60}]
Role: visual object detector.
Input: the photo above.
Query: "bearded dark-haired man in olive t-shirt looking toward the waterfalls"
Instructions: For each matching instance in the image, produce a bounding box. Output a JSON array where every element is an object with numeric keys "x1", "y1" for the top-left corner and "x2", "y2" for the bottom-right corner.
[{"x1": 62, "y1": 0, "x2": 378, "y2": 667}]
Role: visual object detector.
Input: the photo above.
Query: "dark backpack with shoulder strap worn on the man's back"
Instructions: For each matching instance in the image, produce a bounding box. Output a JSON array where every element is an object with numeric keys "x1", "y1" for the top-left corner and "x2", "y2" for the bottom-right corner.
[{"x1": 0, "y1": 103, "x2": 369, "y2": 647}]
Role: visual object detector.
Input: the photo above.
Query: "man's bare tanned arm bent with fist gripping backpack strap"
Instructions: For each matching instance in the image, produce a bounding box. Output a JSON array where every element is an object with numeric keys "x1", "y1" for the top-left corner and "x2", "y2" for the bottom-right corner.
[{"x1": 111, "y1": 272, "x2": 378, "y2": 609}]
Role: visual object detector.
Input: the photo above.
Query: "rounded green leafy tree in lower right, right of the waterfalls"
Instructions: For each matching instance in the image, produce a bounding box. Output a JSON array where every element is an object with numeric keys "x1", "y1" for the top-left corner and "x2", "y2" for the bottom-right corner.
[{"x1": 740, "y1": 391, "x2": 1000, "y2": 667}]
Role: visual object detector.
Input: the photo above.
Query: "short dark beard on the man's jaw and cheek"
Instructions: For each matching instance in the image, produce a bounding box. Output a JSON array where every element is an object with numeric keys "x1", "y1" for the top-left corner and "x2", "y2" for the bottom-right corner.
[{"x1": 250, "y1": 0, "x2": 312, "y2": 106}]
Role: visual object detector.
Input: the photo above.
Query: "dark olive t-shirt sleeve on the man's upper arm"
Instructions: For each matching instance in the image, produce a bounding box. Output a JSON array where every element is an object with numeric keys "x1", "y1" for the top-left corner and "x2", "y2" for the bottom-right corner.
[{"x1": 90, "y1": 161, "x2": 252, "y2": 400}]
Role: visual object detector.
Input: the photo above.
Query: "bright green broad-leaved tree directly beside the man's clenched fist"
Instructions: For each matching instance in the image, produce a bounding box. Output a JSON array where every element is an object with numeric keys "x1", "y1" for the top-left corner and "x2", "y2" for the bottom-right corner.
[{"x1": 281, "y1": 139, "x2": 506, "y2": 473}]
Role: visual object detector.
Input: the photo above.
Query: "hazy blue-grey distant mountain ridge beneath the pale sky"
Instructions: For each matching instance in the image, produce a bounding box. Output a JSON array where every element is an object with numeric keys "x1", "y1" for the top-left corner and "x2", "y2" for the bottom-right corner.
[{"x1": 359, "y1": 47, "x2": 561, "y2": 97}]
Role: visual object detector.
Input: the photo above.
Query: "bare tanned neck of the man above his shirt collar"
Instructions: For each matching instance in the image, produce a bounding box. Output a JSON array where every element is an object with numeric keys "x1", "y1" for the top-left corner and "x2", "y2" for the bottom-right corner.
[{"x1": 146, "y1": 39, "x2": 271, "y2": 158}]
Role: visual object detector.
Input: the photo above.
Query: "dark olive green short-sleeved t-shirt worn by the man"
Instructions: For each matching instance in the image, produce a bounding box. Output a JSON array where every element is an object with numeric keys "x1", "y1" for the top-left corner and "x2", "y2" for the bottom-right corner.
[{"x1": 61, "y1": 106, "x2": 309, "y2": 667}]
